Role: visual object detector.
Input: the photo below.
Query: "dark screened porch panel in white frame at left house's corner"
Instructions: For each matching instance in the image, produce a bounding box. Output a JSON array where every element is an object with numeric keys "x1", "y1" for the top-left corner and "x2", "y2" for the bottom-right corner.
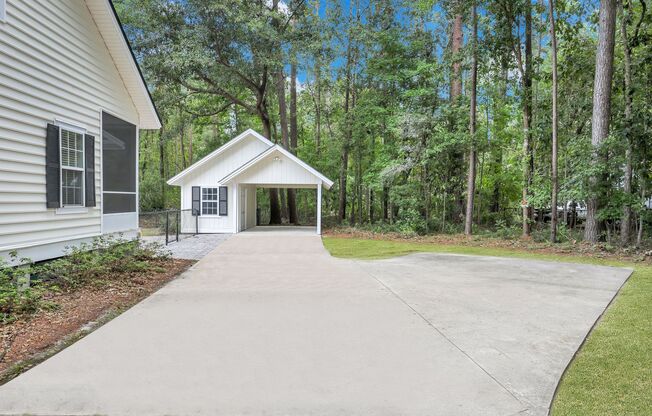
[{"x1": 102, "y1": 112, "x2": 138, "y2": 214}]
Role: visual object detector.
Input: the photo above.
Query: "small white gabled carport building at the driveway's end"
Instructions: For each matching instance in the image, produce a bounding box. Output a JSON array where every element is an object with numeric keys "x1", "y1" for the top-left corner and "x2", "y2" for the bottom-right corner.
[{"x1": 167, "y1": 129, "x2": 333, "y2": 234}]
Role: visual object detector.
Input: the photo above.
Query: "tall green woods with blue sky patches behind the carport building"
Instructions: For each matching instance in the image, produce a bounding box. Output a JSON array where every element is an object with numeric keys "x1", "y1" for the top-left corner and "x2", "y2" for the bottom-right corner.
[{"x1": 114, "y1": 0, "x2": 652, "y2": 245}]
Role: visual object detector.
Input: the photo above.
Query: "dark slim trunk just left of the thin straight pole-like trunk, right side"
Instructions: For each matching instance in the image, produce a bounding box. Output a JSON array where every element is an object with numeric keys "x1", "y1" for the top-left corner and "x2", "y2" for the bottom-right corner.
[{"x1": 522, "y1": 0, "x2": 534, "y2": 238}]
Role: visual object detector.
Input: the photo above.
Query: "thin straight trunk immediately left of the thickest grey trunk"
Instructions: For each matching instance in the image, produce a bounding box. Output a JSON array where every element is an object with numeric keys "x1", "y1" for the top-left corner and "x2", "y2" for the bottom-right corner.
[{"x1": 548, "y1": 0, "x2": 559, "y2": 243}]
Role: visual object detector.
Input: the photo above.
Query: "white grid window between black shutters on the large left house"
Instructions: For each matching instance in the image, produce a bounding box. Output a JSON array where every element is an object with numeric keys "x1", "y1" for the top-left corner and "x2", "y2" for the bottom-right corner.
[{"x1": 59, "y1": 127, "x2": 84, "y2": 207}]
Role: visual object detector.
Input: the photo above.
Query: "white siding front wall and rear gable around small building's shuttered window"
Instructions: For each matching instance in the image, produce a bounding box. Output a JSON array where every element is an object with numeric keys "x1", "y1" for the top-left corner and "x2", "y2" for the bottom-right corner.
[{"x1": 181, "y1": 136, "x2": 268, "y2": 233}]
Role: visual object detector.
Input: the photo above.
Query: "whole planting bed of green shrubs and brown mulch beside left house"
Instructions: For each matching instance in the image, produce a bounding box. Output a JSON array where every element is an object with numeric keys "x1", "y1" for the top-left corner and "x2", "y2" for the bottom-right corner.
[{"x1": 0, "y1": 237, "x2": 192, "y2": 381}]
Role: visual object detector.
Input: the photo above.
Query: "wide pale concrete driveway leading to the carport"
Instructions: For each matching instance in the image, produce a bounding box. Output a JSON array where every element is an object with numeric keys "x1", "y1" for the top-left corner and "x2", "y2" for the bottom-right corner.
[{"x1": 0, "y1": 231, "x2": 630, "y2": 416}]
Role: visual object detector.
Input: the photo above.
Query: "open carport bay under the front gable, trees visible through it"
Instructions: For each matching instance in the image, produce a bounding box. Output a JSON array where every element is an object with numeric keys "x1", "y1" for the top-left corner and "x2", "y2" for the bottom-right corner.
[{"x1": 256, "y1": 188, "x2": 317, "y2": 227}]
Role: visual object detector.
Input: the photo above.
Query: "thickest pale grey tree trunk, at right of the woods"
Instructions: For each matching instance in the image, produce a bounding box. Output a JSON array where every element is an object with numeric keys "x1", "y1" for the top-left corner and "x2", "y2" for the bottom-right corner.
[{"x1": 584, "y1": 0, "x2": 616, "y2": 243}]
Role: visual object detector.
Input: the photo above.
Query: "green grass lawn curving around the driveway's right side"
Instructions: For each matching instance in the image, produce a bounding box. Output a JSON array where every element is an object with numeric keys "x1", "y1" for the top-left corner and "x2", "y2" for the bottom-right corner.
[{"x1": 323, "y1": 237, "x2": 652, "y2": 416}]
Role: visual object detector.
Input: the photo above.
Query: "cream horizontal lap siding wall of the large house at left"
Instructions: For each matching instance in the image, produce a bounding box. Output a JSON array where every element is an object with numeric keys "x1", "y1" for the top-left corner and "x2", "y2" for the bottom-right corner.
[{"x1": 0, "y1": 0, "x2": 139, "y2": 256}]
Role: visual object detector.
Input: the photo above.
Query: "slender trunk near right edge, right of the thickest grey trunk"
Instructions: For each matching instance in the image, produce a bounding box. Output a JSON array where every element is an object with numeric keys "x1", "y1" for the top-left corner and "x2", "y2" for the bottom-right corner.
[{"x1": 618, "y1": 2, "x2": 634, "y2": 246}]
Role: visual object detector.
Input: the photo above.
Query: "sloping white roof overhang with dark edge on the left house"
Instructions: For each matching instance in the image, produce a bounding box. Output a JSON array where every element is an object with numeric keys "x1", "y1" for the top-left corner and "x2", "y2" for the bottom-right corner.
[{"x1": 86, "y1": 0, "x2": 161, "y2": 129}]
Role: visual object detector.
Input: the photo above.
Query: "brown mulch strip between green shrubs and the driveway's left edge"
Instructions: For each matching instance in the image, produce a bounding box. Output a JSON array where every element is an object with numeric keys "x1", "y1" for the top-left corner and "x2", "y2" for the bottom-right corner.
[{"x1": 0, "y1": 259, "x2": 194, "y2": 380}]
